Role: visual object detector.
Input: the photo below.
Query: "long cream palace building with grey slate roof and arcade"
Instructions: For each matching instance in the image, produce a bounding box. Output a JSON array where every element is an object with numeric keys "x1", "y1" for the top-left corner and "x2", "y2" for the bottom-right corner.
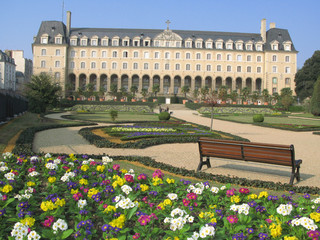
[{"x1": 32, "y1": 12, "x2": 297, "y2": 96}]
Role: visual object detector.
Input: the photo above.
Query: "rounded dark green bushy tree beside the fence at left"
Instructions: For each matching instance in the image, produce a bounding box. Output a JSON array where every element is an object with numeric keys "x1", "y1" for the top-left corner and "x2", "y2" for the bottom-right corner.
[{"x1": 25, "y1": 73, "x2": 62, "y2": 113}]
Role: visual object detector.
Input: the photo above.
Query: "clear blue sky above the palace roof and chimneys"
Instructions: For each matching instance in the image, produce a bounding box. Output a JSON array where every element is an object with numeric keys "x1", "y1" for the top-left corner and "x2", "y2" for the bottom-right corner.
[{"x1": 0, "y1": 0, "x2": 320, "y2": 68}]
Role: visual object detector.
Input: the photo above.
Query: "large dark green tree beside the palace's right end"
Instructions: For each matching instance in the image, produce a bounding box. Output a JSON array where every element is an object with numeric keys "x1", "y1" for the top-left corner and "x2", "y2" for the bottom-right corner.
[{"x1": 294, "y1": 50, "x2": 320, "y2": 101}]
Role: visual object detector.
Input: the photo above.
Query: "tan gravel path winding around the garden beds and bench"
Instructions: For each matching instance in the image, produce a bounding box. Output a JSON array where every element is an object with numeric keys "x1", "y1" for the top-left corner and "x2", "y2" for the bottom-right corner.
[{"x1": 33, "y1": 110, "x2": 320, "y2": 187}]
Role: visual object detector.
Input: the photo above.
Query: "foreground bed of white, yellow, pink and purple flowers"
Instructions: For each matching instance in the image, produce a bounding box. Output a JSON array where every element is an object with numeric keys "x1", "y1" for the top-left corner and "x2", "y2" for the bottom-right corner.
[{"x1": 0, "y1": 153, "x2": 320, "y2": 240}]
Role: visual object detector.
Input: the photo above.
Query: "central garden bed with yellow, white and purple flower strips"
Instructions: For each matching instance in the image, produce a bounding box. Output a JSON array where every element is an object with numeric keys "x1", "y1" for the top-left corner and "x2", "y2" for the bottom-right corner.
[{"x1": 79, "y1": 120, "x2": 248, "y2": 148}]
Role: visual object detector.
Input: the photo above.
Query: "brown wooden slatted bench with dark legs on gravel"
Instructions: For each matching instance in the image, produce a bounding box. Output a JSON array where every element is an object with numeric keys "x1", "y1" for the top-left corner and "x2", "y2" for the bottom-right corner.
[{"x1": 197, "y1": 137, "x2": 302, "y2": 185}]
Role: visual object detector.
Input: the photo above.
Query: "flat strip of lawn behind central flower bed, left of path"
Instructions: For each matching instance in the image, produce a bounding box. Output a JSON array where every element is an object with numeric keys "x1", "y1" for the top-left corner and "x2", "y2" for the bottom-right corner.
[{"x1": 64, "y1": 112, "x2": 159, "y2": 123}]
